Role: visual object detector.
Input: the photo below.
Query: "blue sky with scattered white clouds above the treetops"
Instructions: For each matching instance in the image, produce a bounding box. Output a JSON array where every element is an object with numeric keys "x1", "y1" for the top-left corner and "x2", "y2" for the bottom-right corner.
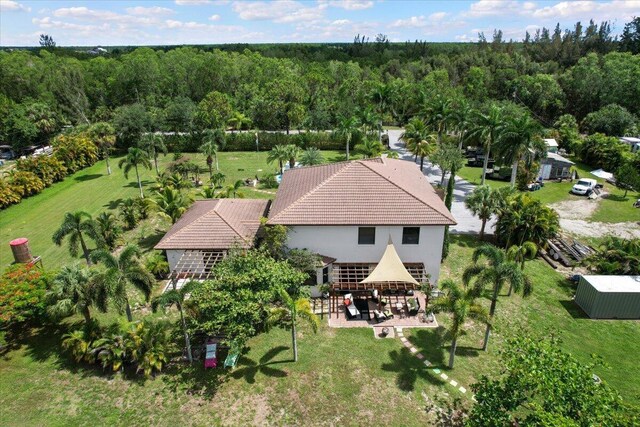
[{"x1": 0, "y1": 0, "x2": 640, "y2": 46}]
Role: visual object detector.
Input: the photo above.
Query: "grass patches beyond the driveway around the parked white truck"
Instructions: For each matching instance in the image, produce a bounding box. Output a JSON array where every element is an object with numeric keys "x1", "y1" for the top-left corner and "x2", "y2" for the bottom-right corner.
[{"x1": 457, "y1": 159, "x2": 640, "y2": 223}]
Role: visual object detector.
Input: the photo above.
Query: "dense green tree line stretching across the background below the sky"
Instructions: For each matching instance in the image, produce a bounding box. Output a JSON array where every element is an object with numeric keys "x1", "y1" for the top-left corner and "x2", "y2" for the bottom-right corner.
[{"x1": 0, "y1": 18, "x2": 640, "y2": 154}]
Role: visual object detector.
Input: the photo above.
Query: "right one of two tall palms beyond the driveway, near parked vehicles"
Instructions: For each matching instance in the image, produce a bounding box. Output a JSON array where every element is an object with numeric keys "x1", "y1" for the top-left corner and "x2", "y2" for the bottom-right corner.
[{"x1": 496, "y1": 113, "x2": 545, "y2": 188}]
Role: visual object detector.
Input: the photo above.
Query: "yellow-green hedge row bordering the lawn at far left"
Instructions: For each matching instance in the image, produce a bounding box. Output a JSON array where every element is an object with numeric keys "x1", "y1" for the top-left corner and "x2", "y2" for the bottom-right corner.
[{"x1": 0, "y1": 134, "x2": 98, "y2": 209}]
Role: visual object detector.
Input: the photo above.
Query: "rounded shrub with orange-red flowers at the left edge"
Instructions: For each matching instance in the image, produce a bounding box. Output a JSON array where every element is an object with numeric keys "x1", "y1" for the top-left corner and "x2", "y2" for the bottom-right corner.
[{"x1": 0, "y1": 264, "x2": 50, "y2": 326}]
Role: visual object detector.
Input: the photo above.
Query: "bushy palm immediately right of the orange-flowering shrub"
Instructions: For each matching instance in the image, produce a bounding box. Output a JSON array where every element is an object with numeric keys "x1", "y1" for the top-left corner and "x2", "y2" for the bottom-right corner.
[{"x1": 47, "y1": 265, "x2": 108, "y2": 324}]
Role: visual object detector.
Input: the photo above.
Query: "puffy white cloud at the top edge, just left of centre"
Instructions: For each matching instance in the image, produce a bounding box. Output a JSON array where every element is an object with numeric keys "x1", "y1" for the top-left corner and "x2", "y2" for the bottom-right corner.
[{"x1": 232, "y1": 0, "x2": 326, "y2": 24}]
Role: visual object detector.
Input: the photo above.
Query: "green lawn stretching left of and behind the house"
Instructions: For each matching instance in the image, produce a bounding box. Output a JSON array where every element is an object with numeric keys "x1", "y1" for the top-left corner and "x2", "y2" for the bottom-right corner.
[{"x1": 0, "y1": 151, "x2": 341, "y2": 269}]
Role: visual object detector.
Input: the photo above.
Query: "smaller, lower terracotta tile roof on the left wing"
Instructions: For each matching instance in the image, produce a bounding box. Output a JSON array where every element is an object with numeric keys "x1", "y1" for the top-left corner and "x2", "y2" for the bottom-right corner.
[{"x1": 155, "y1": 199, "x2": 269, "y2": 249}]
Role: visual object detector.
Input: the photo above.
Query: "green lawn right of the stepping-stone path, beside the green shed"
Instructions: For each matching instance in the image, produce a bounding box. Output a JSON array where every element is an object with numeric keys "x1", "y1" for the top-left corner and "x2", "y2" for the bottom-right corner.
[{"x1": 405, "y1": 236, "x2": 640, "y2": 404}]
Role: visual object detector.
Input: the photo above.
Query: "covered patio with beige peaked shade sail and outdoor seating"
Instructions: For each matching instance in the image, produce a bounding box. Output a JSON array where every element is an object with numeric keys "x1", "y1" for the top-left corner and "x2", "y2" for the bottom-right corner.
[{"x1": 329, "y1": 239, "x2": 437, "y2": 327}]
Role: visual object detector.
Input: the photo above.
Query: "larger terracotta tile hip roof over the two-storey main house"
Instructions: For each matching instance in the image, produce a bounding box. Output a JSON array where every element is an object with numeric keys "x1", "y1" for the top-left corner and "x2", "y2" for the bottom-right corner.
[{"x1": 268, "y1": 159, "x2": 456, "y2": 225}]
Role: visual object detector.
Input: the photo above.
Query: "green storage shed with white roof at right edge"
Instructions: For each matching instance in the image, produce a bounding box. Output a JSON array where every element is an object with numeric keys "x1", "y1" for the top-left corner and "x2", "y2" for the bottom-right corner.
[{"x1": 575, "y1": 276, "x2": 640, "y2": 319}]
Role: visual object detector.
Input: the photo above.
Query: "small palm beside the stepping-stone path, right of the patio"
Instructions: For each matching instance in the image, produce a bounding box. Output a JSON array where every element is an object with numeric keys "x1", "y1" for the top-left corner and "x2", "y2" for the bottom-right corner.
[{"x1": 431, "y1": 279, "x2": 489, "y2": 368}]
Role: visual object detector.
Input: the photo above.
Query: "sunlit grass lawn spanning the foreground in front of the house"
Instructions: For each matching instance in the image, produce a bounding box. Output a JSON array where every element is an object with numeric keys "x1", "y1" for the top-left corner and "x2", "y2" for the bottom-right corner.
[{"x1": 0, "y1": 236, "x2": 640, "y2": 426}]
